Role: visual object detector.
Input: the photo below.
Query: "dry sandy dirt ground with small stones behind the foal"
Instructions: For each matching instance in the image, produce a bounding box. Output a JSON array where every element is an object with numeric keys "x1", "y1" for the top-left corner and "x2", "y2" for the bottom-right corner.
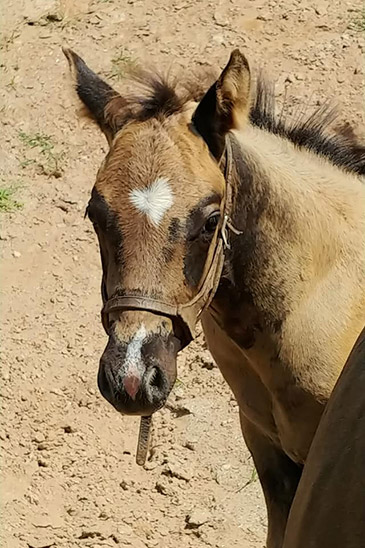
[{"x1": 0, "y1": 0, "x2": 364, "y2": 548}]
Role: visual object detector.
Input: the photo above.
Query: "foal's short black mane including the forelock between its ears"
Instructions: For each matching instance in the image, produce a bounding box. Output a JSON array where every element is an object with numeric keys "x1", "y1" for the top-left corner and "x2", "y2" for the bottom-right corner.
[{"x1": 127, "y1": 72, "x2": 365, "y2": 175}]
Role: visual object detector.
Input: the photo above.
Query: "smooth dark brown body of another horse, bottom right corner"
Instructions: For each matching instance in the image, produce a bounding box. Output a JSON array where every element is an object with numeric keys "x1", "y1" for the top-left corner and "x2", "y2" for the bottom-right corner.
[{"x1": 284, "y1": 329, "x2": 365, "y2": 548}]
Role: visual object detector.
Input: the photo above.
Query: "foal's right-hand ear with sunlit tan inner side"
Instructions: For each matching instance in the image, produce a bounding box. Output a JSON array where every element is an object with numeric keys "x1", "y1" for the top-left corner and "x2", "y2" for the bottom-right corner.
[{"x1": 192, "y1": 49, "x2": 251, "y2": 159}]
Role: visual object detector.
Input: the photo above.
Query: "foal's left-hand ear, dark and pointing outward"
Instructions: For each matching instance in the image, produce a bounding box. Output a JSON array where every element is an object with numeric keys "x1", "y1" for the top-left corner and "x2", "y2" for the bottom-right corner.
[{"x1": 62, "y1": 48, "x2": 126, "y2": 144}]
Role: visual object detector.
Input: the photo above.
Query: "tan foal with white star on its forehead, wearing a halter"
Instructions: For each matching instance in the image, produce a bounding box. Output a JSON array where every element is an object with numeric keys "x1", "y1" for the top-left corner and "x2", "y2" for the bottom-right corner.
[{"x1": 64, "y1": 49, "x2": 365, "y2": 548}]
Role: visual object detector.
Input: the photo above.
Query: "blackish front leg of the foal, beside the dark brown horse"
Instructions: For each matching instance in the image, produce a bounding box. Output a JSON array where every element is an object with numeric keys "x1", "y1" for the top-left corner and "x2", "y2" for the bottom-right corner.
[{"x1": 240, "y1": 412, "x2": 302, "y2": 548}]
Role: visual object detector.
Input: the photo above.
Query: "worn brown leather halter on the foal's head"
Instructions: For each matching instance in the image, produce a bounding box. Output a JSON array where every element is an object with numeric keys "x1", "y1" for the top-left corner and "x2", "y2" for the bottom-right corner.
[{"x1": 101, "y1": 136, "x2": 240, "y2": 347}]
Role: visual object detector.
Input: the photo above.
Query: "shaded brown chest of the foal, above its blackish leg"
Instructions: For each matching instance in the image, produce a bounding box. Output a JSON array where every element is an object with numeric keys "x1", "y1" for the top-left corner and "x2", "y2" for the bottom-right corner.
[{"x1": 202, "y1": 314, "x2": 323, "y2": 463}]
